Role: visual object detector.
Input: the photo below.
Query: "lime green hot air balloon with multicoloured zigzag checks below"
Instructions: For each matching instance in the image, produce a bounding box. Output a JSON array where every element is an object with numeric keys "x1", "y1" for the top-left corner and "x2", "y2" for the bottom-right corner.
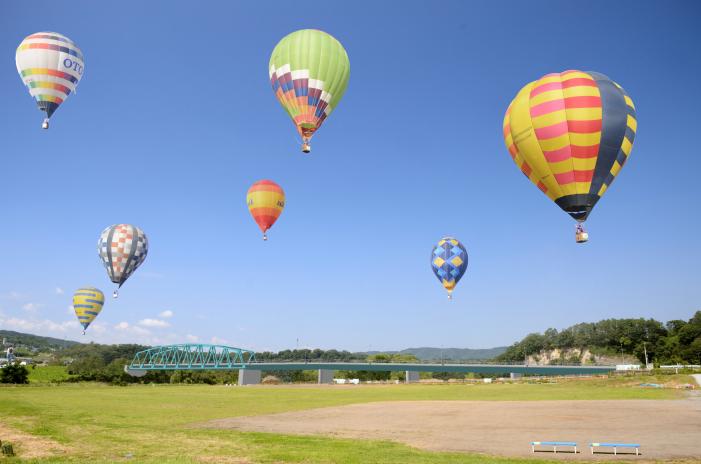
[{"x1": 269, "y1": 29, "x2": 350, "y2": 153}]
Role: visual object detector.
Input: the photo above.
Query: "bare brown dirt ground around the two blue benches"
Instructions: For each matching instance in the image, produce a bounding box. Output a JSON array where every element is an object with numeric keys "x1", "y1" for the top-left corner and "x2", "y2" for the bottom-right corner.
[{"x1": 204, "y1": 398, "x2": 701, "y2": 462}]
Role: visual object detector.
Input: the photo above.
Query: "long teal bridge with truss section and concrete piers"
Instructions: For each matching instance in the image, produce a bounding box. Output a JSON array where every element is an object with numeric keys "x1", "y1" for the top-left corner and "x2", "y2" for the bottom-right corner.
[{"x1": 124, "y1": 344, "x2": 616, "y2": 385}]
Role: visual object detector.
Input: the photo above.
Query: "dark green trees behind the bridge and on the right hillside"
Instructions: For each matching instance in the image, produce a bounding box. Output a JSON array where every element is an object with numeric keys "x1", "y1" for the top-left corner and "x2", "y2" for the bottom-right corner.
[{"x1": 0, "y1": 311, "x2": 701, "y2": 385}]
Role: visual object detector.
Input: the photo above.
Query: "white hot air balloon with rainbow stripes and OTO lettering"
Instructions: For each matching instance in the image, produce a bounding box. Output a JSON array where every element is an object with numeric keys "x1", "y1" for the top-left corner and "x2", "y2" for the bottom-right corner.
[{"x1": 15, "y1": 32, "x2": 85, "y2": 129}]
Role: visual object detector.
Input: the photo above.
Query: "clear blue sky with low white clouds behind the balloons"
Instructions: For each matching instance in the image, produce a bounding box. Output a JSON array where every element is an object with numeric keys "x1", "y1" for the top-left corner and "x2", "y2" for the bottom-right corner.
[{"x1": 0, "y1": 1, "x2": 701, "y2": 350}]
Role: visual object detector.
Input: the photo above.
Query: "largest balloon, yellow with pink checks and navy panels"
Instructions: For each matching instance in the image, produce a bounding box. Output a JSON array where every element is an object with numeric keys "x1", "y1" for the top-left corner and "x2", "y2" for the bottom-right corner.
[{"x1": 504, "y1": 70, "x2": 637, "y2": 243}]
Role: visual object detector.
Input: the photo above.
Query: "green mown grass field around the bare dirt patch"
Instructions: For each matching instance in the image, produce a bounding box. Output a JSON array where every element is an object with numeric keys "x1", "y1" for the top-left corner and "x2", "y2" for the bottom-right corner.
[{"x1": 0, "y1": 376, "x2": 688, "y2": 464}]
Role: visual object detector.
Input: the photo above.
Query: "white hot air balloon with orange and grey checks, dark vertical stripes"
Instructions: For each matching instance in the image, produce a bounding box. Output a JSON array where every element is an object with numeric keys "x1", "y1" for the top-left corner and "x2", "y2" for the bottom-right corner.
[{"x1": 97, "y1": 224, "x2": 148, "y2": 298}]
